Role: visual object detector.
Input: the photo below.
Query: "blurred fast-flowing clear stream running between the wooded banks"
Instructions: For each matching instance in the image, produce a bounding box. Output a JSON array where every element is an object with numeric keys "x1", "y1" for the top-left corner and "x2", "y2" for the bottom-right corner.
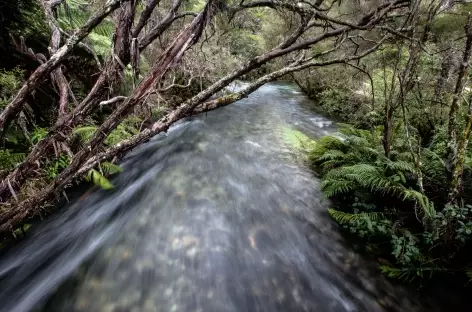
[{"x1": 0, "y1": 84, "x2": 438, "y2": 312}]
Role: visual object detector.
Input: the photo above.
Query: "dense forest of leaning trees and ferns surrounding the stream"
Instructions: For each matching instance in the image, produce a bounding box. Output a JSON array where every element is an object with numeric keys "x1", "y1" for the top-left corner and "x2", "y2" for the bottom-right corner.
[{"x1": 0, "y1": 0, "x2": 472, "y2": 288}]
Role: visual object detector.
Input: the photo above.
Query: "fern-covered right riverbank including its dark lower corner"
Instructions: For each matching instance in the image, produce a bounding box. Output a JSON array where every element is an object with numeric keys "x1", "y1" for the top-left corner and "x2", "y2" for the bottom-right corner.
[{"x1": 296, "y1": 82, "x2": 472, "y2": 304}]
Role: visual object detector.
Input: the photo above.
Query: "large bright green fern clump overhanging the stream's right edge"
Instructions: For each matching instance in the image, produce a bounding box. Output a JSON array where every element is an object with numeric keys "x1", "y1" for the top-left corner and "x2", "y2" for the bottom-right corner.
[{"x1": 311, "y1": 125, "x2": 434, "y2": 218}]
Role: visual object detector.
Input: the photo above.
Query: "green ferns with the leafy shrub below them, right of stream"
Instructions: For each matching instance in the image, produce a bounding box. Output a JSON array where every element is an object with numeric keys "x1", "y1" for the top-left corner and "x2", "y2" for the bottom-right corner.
[{"x1": 309, "y1": 125, "x2": 460, "y2": 281}]
